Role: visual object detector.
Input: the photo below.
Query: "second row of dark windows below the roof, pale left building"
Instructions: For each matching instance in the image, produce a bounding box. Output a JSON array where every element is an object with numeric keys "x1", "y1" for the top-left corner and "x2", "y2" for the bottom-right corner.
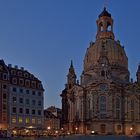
[{"x1": 13, "y1": 97, "x2": 42, "y2": 106}]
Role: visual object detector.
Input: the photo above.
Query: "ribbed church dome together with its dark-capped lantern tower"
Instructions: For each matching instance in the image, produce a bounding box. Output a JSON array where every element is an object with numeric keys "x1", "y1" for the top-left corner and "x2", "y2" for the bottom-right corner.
[{"x1": 84, "y1": 8, "x2": 128, "y2": 71}]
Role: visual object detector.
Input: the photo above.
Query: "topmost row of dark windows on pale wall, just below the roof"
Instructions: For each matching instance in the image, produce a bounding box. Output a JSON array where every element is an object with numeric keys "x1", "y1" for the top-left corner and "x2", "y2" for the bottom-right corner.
[{"x1": 12, "y1": 87, "x2": 41, "y2": 96}]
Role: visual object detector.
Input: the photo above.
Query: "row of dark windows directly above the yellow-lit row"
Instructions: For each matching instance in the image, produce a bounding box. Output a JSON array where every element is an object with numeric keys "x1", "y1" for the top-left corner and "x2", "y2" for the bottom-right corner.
[{"x1": 12, "y1": 107, "x2": 42, "y2": 115}]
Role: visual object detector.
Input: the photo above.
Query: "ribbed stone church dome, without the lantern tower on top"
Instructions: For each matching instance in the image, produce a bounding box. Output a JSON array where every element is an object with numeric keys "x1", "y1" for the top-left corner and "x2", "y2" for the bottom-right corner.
[{"x1": 84, "y1": 39, "x2": 128, "y2": 72}]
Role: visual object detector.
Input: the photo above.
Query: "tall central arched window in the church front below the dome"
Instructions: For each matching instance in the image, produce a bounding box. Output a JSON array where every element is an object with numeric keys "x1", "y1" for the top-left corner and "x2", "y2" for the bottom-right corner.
[{"x1": 100, "y1": 96, "x2": 106, "y2": 119}]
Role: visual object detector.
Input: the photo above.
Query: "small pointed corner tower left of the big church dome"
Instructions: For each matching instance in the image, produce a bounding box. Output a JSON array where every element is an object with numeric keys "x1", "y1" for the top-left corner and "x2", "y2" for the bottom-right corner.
[{"x1": 67, "y1": 60, "x2": 76, "y2": 89}]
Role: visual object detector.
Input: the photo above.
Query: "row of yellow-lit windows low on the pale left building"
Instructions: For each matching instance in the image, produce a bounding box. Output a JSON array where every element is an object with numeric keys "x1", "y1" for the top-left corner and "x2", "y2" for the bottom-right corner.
[{"x1": 11, "y1": 117, "x2": 42, "y2": 124}]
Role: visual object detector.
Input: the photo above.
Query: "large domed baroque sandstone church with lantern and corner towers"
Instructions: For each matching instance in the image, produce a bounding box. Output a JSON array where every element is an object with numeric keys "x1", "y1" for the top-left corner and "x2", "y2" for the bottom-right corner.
[{"x1": 61, "y1": 8, "x2": 140, "y2": 134}]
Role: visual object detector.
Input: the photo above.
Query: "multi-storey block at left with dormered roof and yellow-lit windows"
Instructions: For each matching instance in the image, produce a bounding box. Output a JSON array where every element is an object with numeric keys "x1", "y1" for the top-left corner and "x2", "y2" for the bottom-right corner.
[{"x1": 0, "y1": 60, "x2": 44, "y2": 130}]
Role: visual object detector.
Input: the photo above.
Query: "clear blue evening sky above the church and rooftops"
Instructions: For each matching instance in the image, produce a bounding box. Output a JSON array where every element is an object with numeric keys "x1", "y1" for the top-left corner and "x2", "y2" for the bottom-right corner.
[{"x1": 0, "y1": 0, "x2": 140, "y2": 107}]
